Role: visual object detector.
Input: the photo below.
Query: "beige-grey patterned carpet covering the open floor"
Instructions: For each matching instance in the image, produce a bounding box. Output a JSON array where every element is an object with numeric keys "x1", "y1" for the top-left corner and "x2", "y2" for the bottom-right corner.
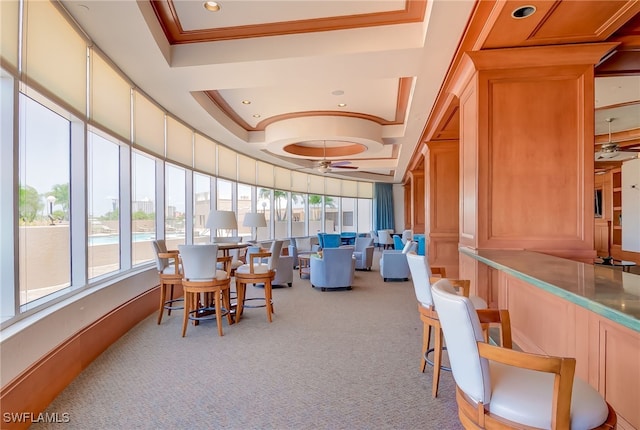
[{"x1": 32, "y1": 251, "x2": 462, "y2": 429}]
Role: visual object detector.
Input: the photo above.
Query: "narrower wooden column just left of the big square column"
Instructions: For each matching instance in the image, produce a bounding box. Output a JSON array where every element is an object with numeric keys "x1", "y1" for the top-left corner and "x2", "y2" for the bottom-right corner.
[{"x1": 424, "y1": 140, "x2": 459, "y2": 278}]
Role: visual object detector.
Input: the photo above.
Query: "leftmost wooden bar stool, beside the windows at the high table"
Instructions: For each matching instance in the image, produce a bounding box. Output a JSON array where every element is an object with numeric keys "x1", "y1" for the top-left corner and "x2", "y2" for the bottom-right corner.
[{"x1": 152, "y1": 239, "x2": 184, "y2": 324}]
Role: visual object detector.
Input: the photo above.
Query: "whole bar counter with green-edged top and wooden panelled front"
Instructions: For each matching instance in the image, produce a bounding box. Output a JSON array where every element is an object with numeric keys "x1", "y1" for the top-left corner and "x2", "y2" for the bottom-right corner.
[{"x1": 459, "y1": 247, "x2": 640, "y2": 430}]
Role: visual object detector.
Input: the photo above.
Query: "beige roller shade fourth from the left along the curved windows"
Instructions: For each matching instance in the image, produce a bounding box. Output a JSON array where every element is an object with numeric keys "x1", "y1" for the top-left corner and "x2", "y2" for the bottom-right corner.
[{"x1": 133, "y1": 91, "x2": 164, "y2": 157}]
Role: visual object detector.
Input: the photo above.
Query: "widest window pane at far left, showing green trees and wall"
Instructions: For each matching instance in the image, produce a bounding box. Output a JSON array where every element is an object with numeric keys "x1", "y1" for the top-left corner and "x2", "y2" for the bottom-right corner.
[{"x1": 18, "y1": 94, "x2": 71, "y2": 305}]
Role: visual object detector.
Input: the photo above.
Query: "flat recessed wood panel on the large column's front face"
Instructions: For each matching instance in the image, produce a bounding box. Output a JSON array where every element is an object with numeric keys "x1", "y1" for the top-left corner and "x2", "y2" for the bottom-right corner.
[{"x1": 485, "y1": 74, "x2": 584, "y2": 242}]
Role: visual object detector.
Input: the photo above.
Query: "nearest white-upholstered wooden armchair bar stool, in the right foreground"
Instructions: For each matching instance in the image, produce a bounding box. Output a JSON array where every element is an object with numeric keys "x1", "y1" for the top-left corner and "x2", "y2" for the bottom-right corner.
[{"x1": 432, "y1": 279, "x2": 617, "y2": 430}]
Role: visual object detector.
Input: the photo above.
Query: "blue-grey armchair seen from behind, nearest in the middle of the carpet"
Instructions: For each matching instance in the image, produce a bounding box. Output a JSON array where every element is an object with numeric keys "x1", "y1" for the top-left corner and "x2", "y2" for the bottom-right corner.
[{"x1": 310, "y1": 247, "x2": 356, "y2": 291}]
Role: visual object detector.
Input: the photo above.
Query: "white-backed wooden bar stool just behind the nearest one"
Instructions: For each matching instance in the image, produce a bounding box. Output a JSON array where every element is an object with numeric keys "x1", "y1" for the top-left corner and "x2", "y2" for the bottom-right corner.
[{"x1": 407, "y1": 252, "x2": 487, "y2": 397}]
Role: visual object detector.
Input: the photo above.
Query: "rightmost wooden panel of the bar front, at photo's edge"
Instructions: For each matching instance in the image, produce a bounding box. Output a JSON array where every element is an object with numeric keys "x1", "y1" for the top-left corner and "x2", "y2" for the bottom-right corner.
[{"x1": 599, "y1": 319, "x2": 640, "y2": 428}]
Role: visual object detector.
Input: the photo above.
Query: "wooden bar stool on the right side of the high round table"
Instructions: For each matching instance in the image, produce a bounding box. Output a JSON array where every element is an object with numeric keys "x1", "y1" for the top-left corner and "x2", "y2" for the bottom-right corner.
[{"x1": 236, "y1": 241, "x2": 278, "y2": 322}]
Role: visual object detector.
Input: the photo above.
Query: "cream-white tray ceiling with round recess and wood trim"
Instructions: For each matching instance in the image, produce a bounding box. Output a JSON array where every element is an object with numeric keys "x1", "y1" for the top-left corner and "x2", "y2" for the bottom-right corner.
[{"x1": 62, "y1": 0, "x2": 640, "y2": 182}]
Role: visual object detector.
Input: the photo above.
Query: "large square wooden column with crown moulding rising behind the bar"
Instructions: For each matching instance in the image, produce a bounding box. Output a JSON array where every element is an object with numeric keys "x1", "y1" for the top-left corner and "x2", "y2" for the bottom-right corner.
[{"x1": 452, "y1": 43, "x2": 615, "y2": 295}]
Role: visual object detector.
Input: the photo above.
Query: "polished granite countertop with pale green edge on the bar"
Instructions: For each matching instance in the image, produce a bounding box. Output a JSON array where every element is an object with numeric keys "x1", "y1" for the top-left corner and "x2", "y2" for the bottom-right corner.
[{"x1": 460, "y1": 248, "x2": 640, "y2": 332}]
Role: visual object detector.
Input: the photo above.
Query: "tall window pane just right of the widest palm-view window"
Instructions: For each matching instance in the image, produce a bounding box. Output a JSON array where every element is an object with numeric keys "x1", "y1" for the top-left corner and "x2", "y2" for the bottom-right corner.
[{"x1": 87, "y1": 132, "x2": 120, "y2": 279}]
